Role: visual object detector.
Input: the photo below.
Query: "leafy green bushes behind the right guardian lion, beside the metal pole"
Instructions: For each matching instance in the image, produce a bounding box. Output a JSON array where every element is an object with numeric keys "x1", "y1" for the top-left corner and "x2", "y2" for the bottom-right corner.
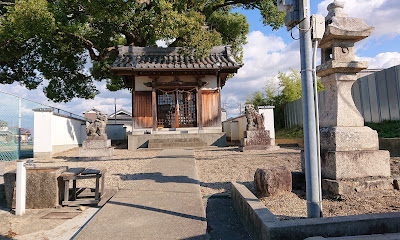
[{"x1": 246, "y1": 68, "x2": 325, "y2": 129}]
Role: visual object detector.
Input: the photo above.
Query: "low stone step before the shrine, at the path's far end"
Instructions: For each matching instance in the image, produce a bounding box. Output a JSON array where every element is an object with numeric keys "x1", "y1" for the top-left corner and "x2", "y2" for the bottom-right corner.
[{"x1": 148, "y1": 138, "x2": 207, "y2": 148}]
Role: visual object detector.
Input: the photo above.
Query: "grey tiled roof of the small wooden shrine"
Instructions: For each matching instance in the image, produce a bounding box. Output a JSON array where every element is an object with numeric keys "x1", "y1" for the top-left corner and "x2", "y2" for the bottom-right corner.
[{"x1": 110, "y1": 46, "x2": 242, "y2": 71}]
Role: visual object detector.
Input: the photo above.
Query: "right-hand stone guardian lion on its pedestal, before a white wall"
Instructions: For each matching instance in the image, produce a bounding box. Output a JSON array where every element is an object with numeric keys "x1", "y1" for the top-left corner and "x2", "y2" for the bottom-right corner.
[{"x1": 240, "y1": 104, "x2": 279, "y2": 151}]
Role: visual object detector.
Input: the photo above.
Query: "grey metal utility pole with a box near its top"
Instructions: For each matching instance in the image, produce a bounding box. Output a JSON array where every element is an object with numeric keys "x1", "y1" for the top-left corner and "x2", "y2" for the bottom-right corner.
[{"x1": 277, "y1": 0, "x2": 322, "y2": 218}]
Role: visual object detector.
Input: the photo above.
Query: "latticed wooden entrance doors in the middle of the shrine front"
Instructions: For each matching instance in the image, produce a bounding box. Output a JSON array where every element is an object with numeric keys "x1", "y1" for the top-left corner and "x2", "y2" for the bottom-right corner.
[{"x1": 157, "y1": 89, "x2": 197, "y2": 128}]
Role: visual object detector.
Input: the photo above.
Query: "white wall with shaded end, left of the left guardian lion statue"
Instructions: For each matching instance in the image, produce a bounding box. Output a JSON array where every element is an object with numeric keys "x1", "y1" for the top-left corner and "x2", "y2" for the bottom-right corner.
[{"x1": 33, "y1": 109, "x2": 86, "y2": 158}]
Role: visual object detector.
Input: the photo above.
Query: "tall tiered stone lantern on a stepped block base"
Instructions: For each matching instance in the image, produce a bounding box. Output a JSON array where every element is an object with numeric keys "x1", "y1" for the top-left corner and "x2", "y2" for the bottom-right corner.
[{"x1": 317, "y1": 0, "x2": 392, "y2": 194}]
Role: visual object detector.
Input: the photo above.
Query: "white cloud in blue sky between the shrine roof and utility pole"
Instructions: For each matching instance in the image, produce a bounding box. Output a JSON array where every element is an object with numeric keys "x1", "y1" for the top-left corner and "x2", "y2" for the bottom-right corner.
[{"x1": 221, "y1": 31, "x2": 300, "y2": 117}]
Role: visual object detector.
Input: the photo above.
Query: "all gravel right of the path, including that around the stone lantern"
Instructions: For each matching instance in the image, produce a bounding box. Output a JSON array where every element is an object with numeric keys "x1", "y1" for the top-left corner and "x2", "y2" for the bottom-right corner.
[{"x1": 195, "y1": 147, "x2": 400, "y2": 220}]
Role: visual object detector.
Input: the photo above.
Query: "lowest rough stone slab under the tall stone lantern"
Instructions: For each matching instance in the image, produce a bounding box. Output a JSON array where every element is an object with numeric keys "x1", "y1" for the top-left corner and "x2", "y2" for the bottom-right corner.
[{"x1": 322, "y1": 178, "x2": 393, "y2": 194}]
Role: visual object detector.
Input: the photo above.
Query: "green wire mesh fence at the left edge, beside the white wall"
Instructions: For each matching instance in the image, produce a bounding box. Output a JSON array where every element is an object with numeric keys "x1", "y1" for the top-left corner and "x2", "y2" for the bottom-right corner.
[{"x1": 0, "y1": 91, "x2": 84, "y2": 162}]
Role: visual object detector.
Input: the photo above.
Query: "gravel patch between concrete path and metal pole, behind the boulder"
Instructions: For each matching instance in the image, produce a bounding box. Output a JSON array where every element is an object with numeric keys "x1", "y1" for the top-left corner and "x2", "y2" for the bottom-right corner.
[{"x1": 195, "y1": 147, "x2": 301, "y2": 196}]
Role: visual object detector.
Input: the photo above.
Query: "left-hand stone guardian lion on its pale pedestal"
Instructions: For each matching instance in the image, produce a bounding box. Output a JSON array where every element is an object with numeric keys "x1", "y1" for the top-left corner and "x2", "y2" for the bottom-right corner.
[{"x1": 79, "y1": 109, "x2": 114, "y2": 160}]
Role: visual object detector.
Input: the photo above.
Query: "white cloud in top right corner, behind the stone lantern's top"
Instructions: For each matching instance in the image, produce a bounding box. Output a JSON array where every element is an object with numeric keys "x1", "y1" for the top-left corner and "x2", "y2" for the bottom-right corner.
[{"x1": 318, "y1": 0, "x2": 400, "y2": 37}]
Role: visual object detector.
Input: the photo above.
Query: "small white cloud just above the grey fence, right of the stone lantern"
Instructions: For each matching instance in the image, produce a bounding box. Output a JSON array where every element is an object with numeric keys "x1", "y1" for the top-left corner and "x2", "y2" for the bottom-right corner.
[{"x1": 356, "y1": 52, "x2": 400, "y2": 69}]
